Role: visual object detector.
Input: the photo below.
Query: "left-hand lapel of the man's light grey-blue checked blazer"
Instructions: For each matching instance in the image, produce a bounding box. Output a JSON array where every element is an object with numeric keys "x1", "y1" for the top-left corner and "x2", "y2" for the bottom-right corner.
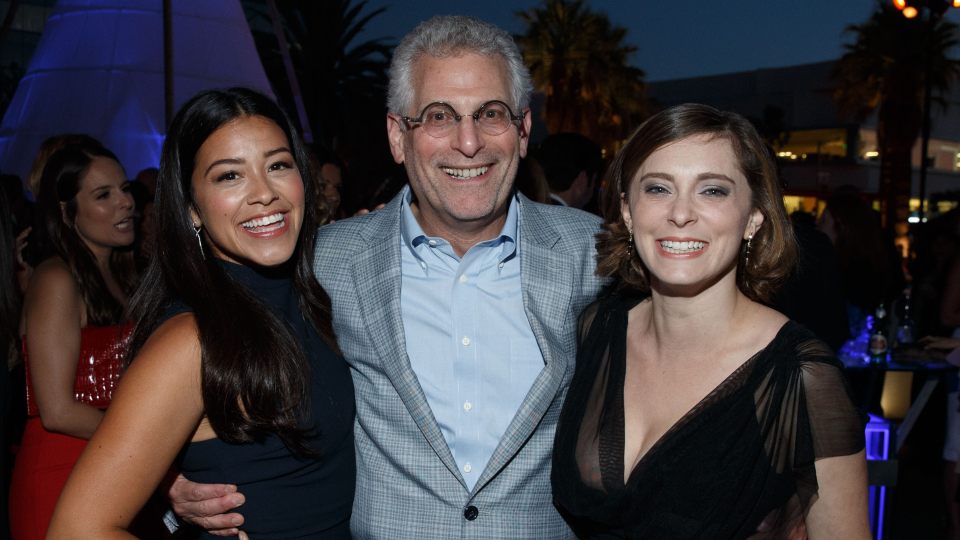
[{"x1": 352, "y1": 190, "x2": 466, "y2": 488}]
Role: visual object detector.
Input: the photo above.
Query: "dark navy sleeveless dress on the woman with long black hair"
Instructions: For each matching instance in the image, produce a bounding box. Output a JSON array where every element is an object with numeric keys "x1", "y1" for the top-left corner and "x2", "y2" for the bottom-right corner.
[{"x1": 166, "y1": 261, "x2": 356, "y2": 540}]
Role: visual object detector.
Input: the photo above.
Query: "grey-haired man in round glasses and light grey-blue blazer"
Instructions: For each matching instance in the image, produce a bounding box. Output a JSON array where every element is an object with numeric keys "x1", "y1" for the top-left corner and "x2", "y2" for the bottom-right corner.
[{"x1": 165, "y1": 17, "x2": 600, "y2": 539}]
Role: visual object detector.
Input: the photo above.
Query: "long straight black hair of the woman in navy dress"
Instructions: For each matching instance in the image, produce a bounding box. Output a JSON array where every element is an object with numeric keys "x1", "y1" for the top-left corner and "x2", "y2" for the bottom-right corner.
[{"x1": 127, "y1": 88, "x2": 339, "y2": 456}]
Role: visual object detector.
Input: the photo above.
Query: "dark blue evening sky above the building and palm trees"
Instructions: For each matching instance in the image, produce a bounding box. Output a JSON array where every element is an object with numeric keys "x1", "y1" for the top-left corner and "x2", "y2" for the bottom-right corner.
[{"x1": 360, "y1": 0, "x2": 960, "y2": 81}]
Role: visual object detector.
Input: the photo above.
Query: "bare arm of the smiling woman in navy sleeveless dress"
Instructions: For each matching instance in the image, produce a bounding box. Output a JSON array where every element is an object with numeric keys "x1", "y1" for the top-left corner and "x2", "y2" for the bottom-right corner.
[{"x1": 47, "y1": 314, "x2": 203, "y2": 539}]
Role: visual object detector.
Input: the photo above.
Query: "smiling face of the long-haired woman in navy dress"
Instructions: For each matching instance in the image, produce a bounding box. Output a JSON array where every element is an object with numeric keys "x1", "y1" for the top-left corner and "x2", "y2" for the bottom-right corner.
[{"x1": 191, "y1": 116, "x2": 304, "y2": 267}]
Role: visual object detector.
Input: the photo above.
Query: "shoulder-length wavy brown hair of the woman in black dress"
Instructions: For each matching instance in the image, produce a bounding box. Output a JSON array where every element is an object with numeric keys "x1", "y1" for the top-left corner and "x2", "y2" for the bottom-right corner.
[{"x1": 597, "y1": 103, "x2": 797, "y2": 302}]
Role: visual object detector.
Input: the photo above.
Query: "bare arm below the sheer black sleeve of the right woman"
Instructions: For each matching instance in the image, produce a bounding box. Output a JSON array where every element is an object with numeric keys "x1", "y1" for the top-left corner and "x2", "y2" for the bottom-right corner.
[{"x1": 806, "y1": 450, "x2": 872, "y2": 540}]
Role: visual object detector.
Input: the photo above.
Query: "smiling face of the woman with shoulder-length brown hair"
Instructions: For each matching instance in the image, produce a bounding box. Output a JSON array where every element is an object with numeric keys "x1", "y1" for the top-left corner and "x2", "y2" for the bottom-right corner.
[{"x1": 621, "y1": 136, "x2": 763, "y2": 293}]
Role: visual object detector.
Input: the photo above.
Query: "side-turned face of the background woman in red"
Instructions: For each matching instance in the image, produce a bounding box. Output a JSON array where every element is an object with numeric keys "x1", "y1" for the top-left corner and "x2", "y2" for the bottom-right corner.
[{"x1": 68, "y1": 156, "x2": 134, "y2": 258}]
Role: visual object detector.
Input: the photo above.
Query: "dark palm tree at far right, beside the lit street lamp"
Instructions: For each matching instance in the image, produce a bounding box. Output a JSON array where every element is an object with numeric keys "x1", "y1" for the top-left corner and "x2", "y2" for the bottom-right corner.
[{"x1": 831, "y1": 2, "x2": 960, "y2": 237}]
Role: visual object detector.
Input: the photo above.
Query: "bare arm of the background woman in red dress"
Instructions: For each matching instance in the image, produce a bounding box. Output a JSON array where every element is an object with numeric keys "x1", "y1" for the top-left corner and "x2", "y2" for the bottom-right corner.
[{"x1": 23, "y1": 259, "x2": 103, "y2": 439}]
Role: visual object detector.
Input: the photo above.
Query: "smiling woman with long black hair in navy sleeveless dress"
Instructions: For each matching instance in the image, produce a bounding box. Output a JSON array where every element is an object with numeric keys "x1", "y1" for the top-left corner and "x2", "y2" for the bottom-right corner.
[{"x1": 50, "y1": 88, "x2": 355, "y2": 539}]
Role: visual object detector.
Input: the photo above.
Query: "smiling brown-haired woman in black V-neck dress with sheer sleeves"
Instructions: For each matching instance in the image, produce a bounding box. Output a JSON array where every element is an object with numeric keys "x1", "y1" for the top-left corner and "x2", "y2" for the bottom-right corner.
[{"x1": 552, "y1": 105, "x2": 870, "y2": 540}]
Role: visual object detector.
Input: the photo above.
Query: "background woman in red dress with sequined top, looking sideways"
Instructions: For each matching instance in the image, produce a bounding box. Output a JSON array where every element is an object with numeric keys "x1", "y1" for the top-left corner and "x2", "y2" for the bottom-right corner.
[{"x1": 10, "y1": 145, "x2": 136, "y2": 540}]
